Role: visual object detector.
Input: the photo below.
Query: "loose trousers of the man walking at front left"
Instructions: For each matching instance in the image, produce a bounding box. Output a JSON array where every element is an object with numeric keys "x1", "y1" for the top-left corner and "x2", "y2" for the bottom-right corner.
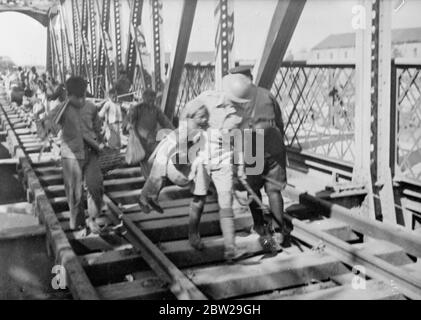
[{"x1": 62, "y1": 150, "x2": 104, "y2": 229}]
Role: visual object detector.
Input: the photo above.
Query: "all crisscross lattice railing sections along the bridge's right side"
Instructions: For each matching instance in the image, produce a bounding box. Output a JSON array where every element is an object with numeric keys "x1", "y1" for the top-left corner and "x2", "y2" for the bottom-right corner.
[{"x1": 172, "y1": 62, "x2": 421, "y2": 183}]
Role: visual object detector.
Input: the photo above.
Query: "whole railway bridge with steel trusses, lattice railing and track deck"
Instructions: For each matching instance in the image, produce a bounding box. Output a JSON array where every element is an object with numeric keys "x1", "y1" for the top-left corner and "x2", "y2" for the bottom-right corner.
[{"x1": 0, "y1": 0, "x2": 421, "y2": 299}]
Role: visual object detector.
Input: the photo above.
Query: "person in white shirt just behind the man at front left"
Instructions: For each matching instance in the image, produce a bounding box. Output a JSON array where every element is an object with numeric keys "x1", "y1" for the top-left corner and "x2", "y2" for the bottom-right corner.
[{"x1": 99, "y1": 89, "x2": 123, "y2": 149}]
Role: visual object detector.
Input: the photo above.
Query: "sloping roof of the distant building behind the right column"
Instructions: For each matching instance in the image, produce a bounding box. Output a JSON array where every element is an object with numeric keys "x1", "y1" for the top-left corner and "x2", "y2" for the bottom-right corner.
[{"x1": 313, "y1": 28, "x2": 421, "y2": 50}]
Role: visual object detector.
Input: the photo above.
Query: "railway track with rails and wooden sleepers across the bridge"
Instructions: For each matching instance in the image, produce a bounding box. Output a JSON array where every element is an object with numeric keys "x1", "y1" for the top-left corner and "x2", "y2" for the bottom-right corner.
[{"x1": 0, "y1": 92, "x2": 421, "y2": 300}]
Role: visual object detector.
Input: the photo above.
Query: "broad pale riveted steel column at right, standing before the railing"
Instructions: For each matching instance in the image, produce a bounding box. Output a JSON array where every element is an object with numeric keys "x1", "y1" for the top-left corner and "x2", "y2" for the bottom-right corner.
[{"x1": 353, "y1": 0, "x2": 396, "y2": 223}]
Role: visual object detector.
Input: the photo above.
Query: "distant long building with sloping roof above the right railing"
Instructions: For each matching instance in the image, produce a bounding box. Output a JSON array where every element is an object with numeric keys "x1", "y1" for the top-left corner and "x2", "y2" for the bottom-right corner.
[{"x1": 307, "y1": 28, "x2": 421, "y2": 64}]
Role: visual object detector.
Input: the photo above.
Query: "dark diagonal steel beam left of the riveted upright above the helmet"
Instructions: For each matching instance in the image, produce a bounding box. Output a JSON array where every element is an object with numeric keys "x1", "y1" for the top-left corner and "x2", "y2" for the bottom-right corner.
[{"x1": 161, "y1": 0, "x2": 197, "y2": 119}]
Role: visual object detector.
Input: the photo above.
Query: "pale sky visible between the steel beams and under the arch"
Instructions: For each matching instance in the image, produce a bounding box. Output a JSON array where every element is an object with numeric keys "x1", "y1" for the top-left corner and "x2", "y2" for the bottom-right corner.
[{"x1": 0, "y1": 0, "x2": 421, "y2": 65}]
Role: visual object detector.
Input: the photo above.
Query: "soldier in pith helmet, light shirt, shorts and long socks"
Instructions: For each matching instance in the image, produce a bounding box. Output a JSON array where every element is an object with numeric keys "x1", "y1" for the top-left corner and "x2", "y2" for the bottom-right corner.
[{"x1": 189, "y1": 75, "x2": 251, "y2": 262}]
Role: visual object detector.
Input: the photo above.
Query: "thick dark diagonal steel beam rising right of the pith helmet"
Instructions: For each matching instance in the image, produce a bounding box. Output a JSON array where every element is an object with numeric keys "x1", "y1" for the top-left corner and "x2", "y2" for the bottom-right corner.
[{"x1": 256, "y1": 0, "x2": 306, "y2": 89}]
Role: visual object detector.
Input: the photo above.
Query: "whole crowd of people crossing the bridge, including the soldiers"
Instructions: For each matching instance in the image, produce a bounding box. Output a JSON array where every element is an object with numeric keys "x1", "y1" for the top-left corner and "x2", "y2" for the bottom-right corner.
[{"x1": 3, "y1": 67, "x2": 291, "y2": 262}]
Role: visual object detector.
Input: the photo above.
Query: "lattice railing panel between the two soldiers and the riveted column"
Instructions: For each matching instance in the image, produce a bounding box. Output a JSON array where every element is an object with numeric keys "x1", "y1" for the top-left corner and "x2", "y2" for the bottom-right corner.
[{"x1": 272, "y1": 62, "x2": 355, "y2": 164}]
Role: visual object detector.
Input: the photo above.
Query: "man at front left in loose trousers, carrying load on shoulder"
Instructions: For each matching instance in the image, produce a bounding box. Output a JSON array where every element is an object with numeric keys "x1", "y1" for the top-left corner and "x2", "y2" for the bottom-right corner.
[{"x1": 47, "y1": 77, "x2": 104, "y2": 233}]
